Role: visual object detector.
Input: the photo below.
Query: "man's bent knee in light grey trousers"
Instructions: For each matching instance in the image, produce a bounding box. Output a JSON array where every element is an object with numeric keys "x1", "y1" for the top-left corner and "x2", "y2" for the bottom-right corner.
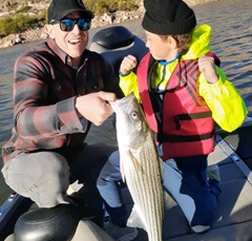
[{"x1": 3, "y1": 152, "x2": 69, "y2": 208}]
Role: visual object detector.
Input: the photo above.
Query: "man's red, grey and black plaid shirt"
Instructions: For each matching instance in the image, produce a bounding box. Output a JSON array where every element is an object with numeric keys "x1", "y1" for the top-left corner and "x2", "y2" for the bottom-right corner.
[{"x1": 2, "y1": 40, "x2": 122, "y2": 163}]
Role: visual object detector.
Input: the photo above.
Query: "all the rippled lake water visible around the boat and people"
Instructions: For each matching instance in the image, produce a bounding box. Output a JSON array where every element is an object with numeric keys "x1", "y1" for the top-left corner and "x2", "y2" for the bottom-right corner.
[{"x1": 0, "y1": 0, "x2": 252, "y2": 204}]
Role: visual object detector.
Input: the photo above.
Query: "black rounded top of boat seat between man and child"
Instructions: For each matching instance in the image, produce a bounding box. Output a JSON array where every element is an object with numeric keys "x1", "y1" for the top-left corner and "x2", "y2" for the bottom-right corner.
[{"x1": 92, "y1": 26, "x2": 134, "y2": 49}]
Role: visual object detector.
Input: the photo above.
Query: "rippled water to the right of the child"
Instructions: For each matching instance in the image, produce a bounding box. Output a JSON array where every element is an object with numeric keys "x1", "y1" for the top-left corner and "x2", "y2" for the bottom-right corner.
[{"x1": 196, "y1": 0, "x2": 252, "y2": 108}]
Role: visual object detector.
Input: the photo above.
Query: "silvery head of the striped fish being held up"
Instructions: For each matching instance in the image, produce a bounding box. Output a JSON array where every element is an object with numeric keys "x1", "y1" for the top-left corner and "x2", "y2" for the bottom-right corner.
[{"x1": 111, "y1": 93, "x2": 150, "y2": 149}]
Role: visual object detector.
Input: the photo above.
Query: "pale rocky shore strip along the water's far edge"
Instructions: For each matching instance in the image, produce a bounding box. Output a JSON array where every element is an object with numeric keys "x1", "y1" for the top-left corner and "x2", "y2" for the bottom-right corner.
[{"x1": 0, "y1": 0, "x2": 218, "y2": 48}]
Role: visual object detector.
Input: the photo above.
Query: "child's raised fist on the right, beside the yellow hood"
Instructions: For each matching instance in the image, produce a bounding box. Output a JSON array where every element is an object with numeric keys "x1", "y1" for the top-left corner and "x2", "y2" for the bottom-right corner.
[{"x1": 198, "y1": 55, "x2": 219, "y2": 84}]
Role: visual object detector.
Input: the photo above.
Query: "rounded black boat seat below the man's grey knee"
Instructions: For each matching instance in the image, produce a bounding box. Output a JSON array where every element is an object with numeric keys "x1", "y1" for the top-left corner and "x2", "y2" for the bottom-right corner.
[{"x1": 14, "y1": 204, "x2": 80, "y2": 241}]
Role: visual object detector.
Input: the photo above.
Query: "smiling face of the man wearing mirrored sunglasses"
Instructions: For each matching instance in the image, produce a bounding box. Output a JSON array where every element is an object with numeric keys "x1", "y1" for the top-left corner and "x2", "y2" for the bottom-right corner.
[{"x1": 47, "y1": 12, "x2": 88, "y2": 60}]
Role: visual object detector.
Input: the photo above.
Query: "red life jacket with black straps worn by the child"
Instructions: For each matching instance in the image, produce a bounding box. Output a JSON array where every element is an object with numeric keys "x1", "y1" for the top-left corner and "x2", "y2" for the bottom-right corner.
[{"x1": 137, "y1": 53, "x2": 214, "y2": 160}]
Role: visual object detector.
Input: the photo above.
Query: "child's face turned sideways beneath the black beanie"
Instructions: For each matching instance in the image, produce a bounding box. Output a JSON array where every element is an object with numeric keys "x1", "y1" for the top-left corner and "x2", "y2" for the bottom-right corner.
[{"x1": 145, "y1": 30, "x2": 179, "y2": 61}]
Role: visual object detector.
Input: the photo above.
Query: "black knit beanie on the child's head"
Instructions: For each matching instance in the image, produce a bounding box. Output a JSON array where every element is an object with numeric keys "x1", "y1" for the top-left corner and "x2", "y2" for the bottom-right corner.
[{"x1": 142, "y1": 0, "x2": 196, "y2": 35}]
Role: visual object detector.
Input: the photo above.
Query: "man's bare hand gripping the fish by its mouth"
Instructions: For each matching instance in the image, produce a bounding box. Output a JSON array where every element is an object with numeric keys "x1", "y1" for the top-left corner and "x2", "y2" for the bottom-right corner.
[{"x1": 75, "y1": 91, "x2": 116, "y2": 126}]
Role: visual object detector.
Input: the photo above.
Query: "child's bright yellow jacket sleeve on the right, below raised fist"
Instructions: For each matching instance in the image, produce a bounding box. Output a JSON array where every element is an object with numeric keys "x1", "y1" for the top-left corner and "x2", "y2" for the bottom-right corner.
[{"x1": 199, "y1": 67, "x2": 248, "y2": 132}]
